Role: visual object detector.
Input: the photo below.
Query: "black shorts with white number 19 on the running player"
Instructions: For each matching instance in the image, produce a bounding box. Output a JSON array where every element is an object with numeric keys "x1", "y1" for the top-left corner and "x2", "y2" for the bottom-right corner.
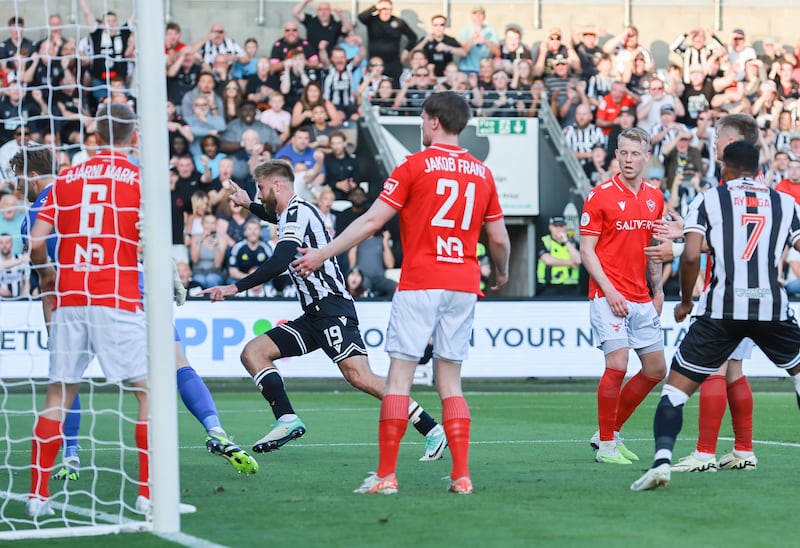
[{"x1": 265, "y1": 314, "x2": 367, "y2": 363}]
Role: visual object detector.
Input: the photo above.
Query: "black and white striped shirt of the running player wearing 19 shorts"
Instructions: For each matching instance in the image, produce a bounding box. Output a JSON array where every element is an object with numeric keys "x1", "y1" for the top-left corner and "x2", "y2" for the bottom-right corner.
[{"x1": 278, "y1": 196, "x2": 352, "y2": 310}]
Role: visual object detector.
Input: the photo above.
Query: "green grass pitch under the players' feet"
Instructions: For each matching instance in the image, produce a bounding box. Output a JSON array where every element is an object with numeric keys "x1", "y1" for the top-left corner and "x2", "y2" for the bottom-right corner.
[{"x1": 0, "y1": 380, "x2": 800, "y2": 548}]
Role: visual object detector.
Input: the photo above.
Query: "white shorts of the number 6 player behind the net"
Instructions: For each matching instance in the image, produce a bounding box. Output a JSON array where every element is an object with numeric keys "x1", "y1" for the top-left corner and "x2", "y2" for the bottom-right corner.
[{"x1": 50, "y1": 306, "x2": 147, "y2": 384}]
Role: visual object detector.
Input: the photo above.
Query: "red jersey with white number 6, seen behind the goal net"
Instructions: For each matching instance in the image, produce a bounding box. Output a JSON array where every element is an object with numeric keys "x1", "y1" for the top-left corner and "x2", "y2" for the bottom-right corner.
[{"x1": 39, "y1": 152, "x2": 142, "y2": 311}]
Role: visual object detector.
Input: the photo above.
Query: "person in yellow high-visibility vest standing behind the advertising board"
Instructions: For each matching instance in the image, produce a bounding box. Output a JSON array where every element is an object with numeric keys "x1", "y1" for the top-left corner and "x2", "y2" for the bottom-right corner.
[{"x1": 536, "y1": 216, "x2": 581, "y2": 295}]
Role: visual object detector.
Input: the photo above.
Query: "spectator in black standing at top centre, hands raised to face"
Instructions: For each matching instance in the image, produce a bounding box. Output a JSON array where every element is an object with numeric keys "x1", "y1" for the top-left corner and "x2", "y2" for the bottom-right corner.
[{"x1": 358, "y1": 0, "x2": 417, "y2": 85}]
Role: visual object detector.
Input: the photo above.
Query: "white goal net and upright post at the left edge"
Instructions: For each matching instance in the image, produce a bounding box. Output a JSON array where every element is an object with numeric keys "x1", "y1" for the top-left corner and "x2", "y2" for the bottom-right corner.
[{"x1": 0, "y1": 0, "x2": 180, "y2": 540}]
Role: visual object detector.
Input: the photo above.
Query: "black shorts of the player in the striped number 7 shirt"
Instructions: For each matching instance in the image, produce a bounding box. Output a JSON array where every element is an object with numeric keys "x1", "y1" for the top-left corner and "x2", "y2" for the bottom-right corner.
[{"x1": 671, "y1": 317, "x2": 800, "y2": 382}]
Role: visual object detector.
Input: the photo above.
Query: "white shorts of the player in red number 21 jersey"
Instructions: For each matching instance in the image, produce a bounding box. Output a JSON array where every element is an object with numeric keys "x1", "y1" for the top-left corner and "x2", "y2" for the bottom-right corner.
[{"x1": 386, "y1": 289, "x2": 478, "y2": 363}]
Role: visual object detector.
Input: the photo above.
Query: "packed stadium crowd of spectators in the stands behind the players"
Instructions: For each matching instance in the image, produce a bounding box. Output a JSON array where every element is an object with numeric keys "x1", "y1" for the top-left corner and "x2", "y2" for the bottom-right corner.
[{"x1": 0, "y1": 0, "x2": 800, "y2": 298}]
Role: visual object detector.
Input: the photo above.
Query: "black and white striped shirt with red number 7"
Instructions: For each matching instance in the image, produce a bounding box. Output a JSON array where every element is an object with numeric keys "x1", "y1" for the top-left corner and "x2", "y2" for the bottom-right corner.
[{"x1": 684, "y1": 178, "x2": 800, "y2": 321}]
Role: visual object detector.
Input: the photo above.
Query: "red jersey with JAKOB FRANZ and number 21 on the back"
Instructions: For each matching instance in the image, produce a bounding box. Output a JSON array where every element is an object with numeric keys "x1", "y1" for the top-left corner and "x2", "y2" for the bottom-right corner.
[{"x1": 378, "y1": 143, "x2": 503, "y2": 295}]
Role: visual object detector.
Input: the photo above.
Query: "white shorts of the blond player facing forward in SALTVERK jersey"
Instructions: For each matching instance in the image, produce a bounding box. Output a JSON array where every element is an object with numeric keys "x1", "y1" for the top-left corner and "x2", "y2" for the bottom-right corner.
[{"x1": 589, "y1": 297, "x2": 664, "y2": 354}]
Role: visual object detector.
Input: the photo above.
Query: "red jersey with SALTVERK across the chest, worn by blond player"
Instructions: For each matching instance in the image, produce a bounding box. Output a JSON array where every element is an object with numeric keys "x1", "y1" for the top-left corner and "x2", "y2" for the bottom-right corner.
[{"x1": 581, "y1": 175, "x2": 664, "y2": 303}]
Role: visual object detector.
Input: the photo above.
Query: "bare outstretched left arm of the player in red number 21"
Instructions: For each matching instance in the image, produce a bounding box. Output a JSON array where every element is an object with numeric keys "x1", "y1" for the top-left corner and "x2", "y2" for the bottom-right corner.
[{"x1": 292, "y1": 200, "x2": 397, "y2": 277}]
